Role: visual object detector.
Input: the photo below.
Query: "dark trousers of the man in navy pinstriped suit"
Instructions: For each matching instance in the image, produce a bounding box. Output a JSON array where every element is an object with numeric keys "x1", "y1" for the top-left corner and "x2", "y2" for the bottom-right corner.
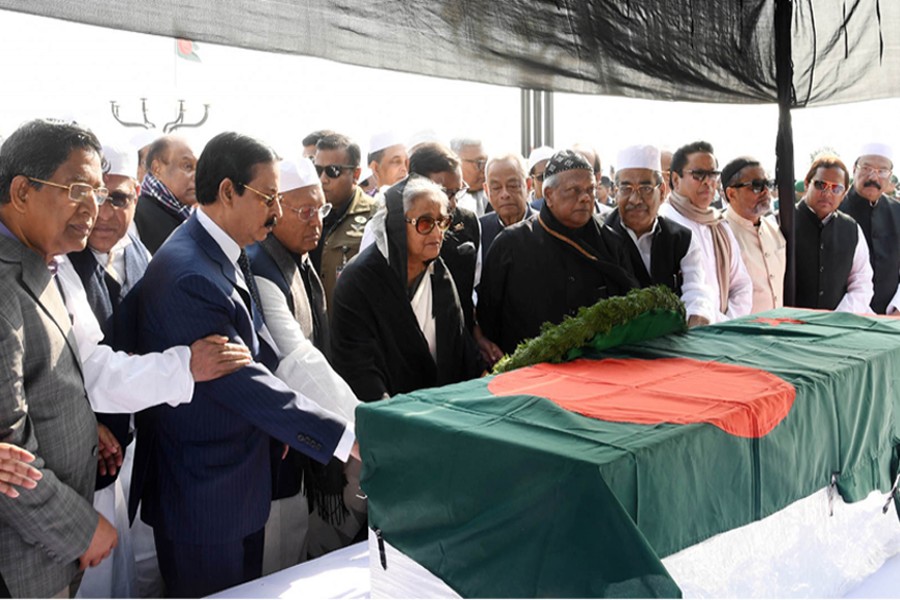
[{"x1": 153, "y1": 529, "x2": 265, "y2": 598}]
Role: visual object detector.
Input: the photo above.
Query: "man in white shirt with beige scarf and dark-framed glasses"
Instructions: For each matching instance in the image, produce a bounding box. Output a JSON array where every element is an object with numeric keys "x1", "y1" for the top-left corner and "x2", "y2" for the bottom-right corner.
[{"x1": 659, "y1": 141, "x2": 753, "y2": 323}]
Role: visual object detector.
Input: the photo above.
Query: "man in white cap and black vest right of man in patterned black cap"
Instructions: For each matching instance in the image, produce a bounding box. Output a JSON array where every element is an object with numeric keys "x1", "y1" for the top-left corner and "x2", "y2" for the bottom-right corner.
[{"x1": 606, "y1": 145, "x2": 715, "y2": 327}]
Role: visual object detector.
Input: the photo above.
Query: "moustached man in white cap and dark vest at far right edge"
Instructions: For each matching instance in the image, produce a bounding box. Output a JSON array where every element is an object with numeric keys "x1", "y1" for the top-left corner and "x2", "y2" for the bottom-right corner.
[{"x1": 841, "y1": 143, "x2": 900, "y2": 314}]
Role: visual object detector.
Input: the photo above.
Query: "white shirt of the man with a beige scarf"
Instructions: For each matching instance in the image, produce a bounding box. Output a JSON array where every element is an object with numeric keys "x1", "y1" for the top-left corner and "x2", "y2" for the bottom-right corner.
[{"x1": 659, "y1": 202, "x2": 753, "y2": 323}]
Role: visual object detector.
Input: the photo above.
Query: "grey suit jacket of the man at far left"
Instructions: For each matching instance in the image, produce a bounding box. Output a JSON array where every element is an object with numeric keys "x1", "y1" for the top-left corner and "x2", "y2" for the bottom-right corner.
[{"x1": 0, "y1": 235, "x2": 98, "y2": 598}]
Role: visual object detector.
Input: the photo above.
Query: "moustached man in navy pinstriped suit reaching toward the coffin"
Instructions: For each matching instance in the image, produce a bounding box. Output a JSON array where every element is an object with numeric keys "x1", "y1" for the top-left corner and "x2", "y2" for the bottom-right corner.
[{"x1": 131, "y1": 132, "x2": 358, "y2": 597}]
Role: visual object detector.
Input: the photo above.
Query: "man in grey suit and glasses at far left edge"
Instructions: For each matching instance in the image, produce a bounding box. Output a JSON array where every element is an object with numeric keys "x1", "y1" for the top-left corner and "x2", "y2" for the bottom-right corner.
[{"x1": 0, "y1": 121, "x2": 117, "y2": 598}]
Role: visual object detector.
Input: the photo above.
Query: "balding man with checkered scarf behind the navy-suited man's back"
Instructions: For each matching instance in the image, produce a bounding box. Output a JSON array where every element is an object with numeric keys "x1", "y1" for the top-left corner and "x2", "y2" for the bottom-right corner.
[{"x1": 134, "y1": 135, "x2": 197, "y2": 253}]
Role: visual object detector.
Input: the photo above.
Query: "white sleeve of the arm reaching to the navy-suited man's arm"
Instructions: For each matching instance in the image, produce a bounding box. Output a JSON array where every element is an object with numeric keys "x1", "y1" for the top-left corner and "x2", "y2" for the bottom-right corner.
[{"x1": 56, "y1": 256, "x2": 194, "y2": 413}]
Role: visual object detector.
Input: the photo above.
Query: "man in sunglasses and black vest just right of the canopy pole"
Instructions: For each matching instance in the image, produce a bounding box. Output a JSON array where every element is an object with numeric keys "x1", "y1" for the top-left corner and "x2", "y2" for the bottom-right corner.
[{"x1": 794, "y1": 155, "x2": 873, "y2": 314}]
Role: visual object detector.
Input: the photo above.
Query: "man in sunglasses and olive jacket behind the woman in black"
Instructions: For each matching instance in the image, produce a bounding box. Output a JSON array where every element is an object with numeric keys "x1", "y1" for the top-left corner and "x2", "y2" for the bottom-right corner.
[{"x1": 310, "y1": 133, "x2": 378, "y2": 310}]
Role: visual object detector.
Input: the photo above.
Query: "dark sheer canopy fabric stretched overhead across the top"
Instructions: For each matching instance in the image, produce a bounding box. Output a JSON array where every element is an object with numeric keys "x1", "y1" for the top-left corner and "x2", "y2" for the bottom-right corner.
[{"x1": 7, "y1": 0, "x2": 900, "y2": 106}]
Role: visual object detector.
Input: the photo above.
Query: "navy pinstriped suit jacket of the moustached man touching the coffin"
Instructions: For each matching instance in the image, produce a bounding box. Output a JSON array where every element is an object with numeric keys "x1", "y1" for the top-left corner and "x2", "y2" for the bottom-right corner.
[{"x1": 126, "y1": 215, "x2": 345, "y2": 544}]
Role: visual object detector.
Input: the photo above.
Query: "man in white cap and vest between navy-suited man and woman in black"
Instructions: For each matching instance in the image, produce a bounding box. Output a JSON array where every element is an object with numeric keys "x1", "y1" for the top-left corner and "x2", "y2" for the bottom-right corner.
[{"x1": 247, "y1": 158, "x2": 366, "y2": 575}]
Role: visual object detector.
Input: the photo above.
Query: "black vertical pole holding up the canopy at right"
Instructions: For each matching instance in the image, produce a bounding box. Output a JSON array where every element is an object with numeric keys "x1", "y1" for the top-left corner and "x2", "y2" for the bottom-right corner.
[{"x1": 775, "y1": 0, "x2": 797, "y2": 306}]
